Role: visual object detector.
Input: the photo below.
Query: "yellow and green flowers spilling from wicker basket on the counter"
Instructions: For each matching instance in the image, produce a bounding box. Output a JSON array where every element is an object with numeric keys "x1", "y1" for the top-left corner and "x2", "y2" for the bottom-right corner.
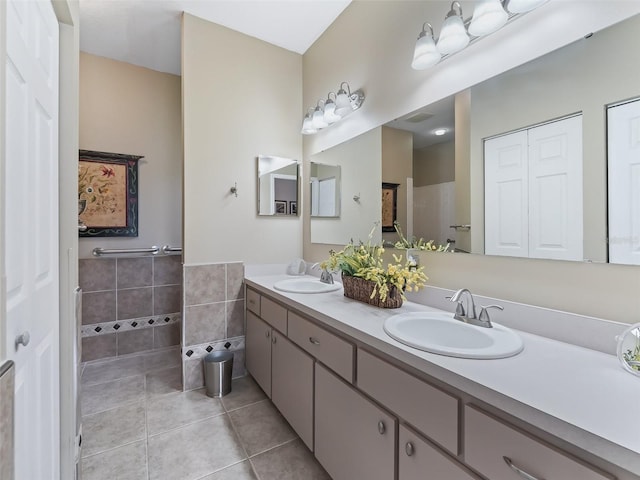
[{"x1": 321, "y1": 227, "x2": 428, "y2": 306}]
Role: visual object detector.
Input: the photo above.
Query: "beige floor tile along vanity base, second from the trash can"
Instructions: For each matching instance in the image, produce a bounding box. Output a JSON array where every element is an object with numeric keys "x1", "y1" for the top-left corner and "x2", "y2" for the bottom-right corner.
[{"x1": 229, "y1": 400, "x2": 296, "y2": 457}]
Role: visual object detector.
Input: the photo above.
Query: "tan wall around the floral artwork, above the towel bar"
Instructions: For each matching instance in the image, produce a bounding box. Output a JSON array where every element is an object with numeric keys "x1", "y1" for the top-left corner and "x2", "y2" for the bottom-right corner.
[{"x1": 76, "y1": 53, "x2": 182, "y2": 258}]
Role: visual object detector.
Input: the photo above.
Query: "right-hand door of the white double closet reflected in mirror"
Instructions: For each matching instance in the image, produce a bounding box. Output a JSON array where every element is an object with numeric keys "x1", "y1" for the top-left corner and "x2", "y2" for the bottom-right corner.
[{"x1": 528, "y1": 115, "x2": 583, "y2": 261}]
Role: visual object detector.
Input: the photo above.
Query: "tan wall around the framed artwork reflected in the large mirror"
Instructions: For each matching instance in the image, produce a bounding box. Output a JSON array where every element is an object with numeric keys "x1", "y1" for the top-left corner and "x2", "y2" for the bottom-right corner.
[{"x1": 382, "y1": 127, "x2": 413, "y2": 243}]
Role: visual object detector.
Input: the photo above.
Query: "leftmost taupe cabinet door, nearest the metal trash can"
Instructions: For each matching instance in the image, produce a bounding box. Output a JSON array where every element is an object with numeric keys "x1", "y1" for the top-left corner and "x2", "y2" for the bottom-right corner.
[{"x1": 245, "y1": 311, "x2": 271, "y2": 398}]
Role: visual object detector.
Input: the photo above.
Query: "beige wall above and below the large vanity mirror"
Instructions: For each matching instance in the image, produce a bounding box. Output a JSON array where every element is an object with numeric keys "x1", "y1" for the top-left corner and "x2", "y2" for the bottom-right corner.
[{"x1": 304, "y1": 1, "x2": 640, "y2": 322}]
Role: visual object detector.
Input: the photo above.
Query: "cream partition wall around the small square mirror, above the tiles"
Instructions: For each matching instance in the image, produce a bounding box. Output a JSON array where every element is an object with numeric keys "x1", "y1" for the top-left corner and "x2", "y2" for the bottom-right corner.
[{"x1": 182, "y1": 14, "x2": 308, "y2": 264}]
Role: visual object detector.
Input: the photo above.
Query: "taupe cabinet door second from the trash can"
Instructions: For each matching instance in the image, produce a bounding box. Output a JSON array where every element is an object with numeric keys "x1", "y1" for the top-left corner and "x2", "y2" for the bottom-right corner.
[{"x1": 271, "y1": 330, "x2": 313, "y2": 451}]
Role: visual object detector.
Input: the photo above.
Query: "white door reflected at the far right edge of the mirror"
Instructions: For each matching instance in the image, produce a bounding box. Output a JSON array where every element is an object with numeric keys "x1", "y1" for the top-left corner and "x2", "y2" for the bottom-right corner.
[{"x1": 607, "y1": 100, "x2": 640, "y2": 265}]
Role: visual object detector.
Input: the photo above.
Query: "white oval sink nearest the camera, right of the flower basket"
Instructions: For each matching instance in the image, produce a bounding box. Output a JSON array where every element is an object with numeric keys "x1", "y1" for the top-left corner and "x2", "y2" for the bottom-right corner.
[{"x1": 384, "y1": 312, "x2": 524, "y2": 359}]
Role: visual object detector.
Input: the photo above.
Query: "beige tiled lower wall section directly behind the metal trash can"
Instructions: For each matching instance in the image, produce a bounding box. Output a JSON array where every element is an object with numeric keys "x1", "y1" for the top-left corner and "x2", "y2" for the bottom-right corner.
[{"x1": 182, "y1": 262, "x2": 245, "y2": 390}]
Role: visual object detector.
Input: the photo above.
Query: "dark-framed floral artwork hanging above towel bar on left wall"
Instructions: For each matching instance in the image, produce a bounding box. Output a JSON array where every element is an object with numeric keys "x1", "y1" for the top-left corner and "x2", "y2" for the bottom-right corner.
[{"x1": 78, "y1": 150, "x2": 143, "y2": 237}]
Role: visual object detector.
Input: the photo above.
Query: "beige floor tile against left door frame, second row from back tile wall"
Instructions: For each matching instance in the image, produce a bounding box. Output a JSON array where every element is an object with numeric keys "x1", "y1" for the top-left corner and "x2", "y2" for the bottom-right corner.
[{"x1": 81, "y1": 375, "x2": 144, "y2": 415}]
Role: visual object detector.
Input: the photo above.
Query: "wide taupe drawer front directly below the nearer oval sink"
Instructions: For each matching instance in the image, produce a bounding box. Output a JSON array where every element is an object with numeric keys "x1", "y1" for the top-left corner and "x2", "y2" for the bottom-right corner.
[{"x1": 358, "y1": 349, "x2": 458, "y2": 455}]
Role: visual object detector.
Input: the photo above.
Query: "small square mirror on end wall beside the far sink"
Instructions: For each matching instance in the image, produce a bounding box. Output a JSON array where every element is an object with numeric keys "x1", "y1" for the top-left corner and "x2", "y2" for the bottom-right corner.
[{"x1": 257, "y1": 155, "x2": 299, "y2": 216}]
